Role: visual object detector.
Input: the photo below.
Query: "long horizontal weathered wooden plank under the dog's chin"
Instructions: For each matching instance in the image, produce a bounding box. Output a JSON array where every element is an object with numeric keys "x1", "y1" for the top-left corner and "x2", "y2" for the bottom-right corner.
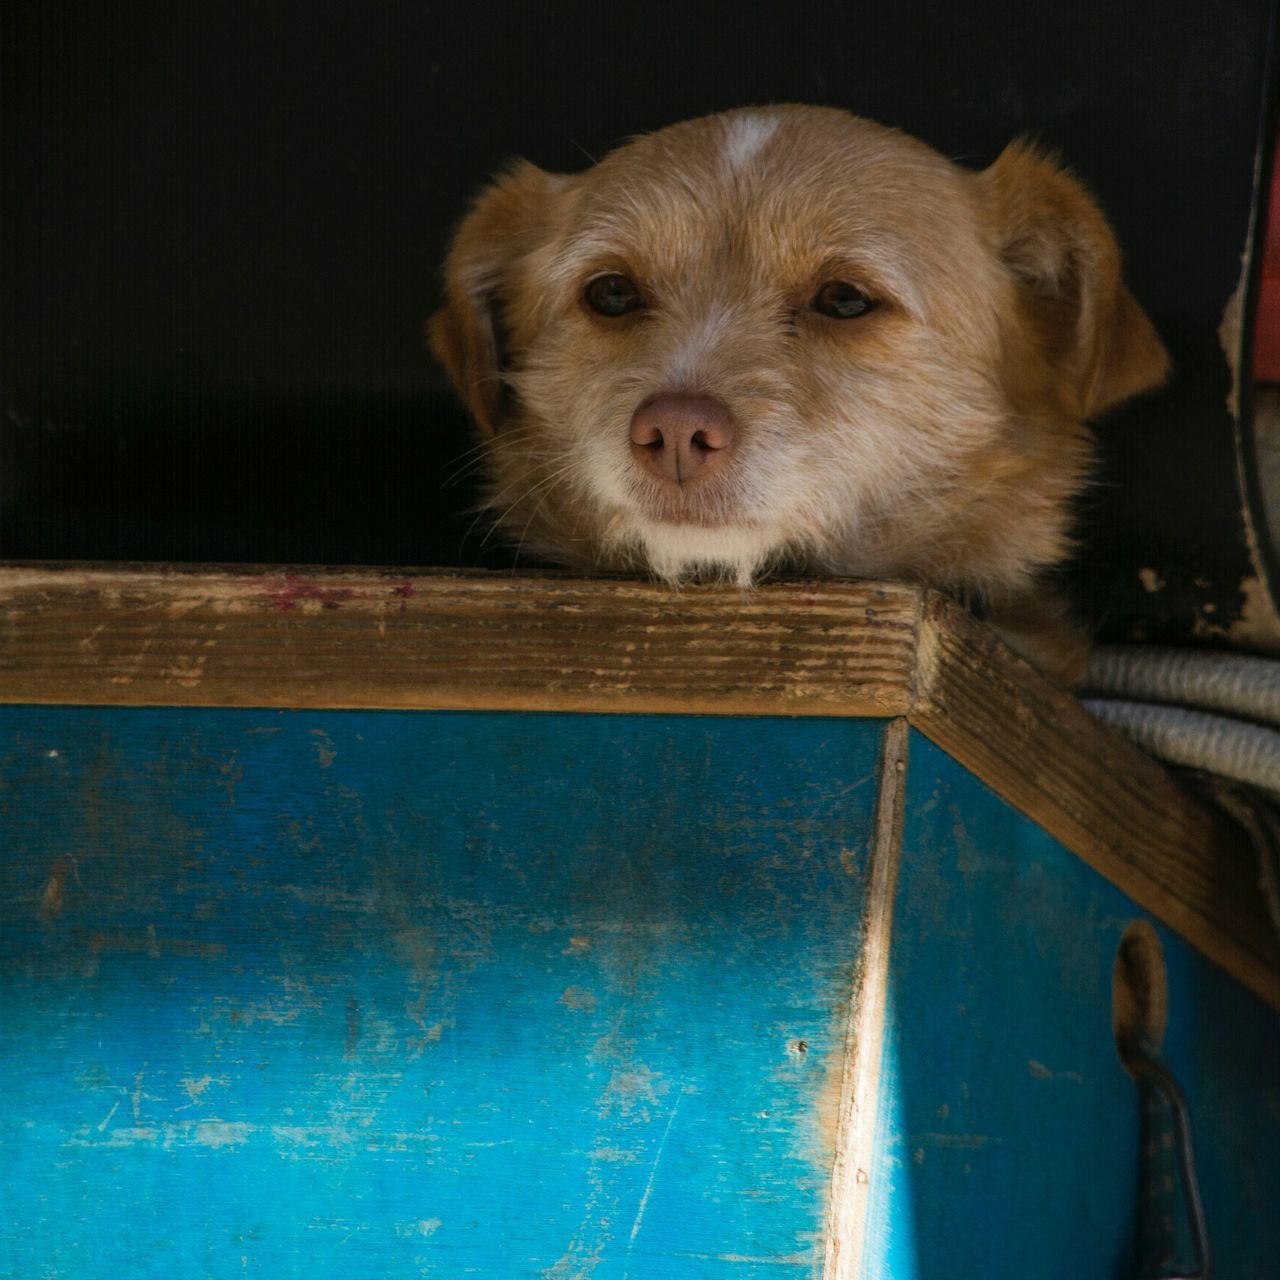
[{"x1": 0, "y1": 564, "x2": 919, "y2": 716}]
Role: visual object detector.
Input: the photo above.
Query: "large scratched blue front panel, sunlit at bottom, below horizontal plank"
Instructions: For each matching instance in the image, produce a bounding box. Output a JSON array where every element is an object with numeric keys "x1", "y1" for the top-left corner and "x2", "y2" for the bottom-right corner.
[{"x1": 0, "y1": 708, "x2": 879, "y2": 1280}]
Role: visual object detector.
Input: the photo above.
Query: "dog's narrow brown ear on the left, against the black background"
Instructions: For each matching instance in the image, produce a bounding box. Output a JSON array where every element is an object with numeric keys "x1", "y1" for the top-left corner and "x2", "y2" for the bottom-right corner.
[{"x1": 428, "y1": 161, "x2": 566, "y2": 435}]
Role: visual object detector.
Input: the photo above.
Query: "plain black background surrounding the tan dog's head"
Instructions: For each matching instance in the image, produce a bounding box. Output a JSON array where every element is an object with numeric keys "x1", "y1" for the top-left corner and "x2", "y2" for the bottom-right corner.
[{"x1": 0, "y1": 0, "x2": 1274, "y2": 637}]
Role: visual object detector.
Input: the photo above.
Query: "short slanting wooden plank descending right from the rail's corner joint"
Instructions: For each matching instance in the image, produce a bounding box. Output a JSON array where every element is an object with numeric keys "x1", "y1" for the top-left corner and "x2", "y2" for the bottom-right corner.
[{"x1": 910, "y1": 595, "x2": 1280, "y2": 1006}]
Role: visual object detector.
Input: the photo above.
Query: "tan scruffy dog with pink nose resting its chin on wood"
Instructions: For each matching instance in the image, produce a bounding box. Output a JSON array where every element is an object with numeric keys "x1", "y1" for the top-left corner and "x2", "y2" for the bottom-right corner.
[{"x1": 431, "y1": 106, "x2": 1167, "y2": 680}]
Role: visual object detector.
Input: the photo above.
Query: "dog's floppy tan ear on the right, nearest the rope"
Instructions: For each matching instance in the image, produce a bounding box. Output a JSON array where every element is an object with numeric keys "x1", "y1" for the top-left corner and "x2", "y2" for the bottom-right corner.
[{"x1": 978, "y1": 142, "x2": 1169, "y2": 419}]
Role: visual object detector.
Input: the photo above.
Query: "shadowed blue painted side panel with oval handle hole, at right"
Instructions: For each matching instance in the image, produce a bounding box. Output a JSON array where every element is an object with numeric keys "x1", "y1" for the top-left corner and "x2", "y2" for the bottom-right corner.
[{"x1": 865, "y1": 733, "x2": 1280, "y2": 1280}]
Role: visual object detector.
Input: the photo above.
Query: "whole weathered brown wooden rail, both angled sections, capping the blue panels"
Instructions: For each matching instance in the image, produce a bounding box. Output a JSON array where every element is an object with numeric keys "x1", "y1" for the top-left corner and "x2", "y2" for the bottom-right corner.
[{"x1": 0, "y1": 563, "x2": 1280, "y2": 1007}]
